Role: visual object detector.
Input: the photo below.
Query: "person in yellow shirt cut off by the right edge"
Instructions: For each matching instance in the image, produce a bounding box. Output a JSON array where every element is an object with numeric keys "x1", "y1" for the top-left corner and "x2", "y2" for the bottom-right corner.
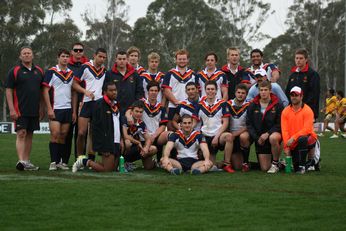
[{"x1": 330, "y1": 91, "x2": 346, "y2": 139}]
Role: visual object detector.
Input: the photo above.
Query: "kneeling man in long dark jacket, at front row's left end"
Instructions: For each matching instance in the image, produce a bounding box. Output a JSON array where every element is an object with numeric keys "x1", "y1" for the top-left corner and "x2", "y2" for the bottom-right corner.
[{"x1": 72, "y1": 82, "x2": 120, "y2": 172}]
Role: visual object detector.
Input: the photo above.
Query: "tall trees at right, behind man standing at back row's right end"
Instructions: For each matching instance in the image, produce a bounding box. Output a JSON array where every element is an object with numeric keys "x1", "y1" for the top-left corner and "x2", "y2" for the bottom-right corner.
[{"x1": 264, "y1": 0, "x2": 345, "y2": 106}]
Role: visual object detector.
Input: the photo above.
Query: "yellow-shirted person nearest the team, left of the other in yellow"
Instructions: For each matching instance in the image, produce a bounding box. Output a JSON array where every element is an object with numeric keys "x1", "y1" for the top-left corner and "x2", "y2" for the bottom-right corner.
[{"x1": 317, "y1": 89, "x2": 338, "y2": 136}]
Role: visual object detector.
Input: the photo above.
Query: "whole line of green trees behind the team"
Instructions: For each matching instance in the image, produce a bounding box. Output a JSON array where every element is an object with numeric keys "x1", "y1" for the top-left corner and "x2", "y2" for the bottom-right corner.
[{"x1": 0, "y1": 0, "x2": 346, "y2": 121}]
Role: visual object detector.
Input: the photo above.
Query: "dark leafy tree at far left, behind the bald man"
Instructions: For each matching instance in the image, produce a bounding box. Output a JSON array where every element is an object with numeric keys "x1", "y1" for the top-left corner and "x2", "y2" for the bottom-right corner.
[{"x1": 0, "y1": 0, "x2": 72, "y2": 121}]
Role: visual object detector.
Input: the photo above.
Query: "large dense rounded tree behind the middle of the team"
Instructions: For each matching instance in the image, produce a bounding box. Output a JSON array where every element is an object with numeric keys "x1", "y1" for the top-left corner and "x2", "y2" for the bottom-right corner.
[{"x1": 133, "y1": 0, "x2": 246, "y2": 70}]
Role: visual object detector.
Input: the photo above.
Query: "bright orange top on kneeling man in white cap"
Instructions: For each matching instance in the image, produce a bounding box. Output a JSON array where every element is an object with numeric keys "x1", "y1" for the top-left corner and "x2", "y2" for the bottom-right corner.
[{"x1": 281, "y1": 104, "x2": 317, "y2": 149}]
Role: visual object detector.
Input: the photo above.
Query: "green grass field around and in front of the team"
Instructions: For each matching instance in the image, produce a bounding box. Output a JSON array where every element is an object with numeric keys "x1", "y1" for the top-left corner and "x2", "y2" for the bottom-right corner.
[{"x1": 0, "y1": 135, "x2": 346, "y2": 230}]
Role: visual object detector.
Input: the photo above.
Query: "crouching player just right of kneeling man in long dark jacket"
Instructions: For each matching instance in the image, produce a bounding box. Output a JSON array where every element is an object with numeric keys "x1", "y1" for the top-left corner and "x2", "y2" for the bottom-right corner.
[{"x1": 122, "y1": 100, "x2": 157, "y2": 171}]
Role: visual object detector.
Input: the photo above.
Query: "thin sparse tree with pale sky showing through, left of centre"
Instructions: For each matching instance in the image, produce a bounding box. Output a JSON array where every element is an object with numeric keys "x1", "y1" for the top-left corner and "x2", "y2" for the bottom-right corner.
[{"x1": 84, "y1": 0, "x2": 132, "y2": 67}]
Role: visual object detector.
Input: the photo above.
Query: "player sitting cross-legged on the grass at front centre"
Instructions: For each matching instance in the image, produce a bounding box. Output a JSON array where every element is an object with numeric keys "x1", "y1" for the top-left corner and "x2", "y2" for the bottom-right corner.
[{"x1": 161, "y1": 114, "x2": 213, "y2": 175}]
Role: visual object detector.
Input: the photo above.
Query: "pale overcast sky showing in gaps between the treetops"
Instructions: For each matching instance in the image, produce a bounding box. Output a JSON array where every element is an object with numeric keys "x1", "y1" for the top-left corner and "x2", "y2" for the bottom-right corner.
[{"x1": 70, "y1": 0, "x2": 293, "y2": 48}]
